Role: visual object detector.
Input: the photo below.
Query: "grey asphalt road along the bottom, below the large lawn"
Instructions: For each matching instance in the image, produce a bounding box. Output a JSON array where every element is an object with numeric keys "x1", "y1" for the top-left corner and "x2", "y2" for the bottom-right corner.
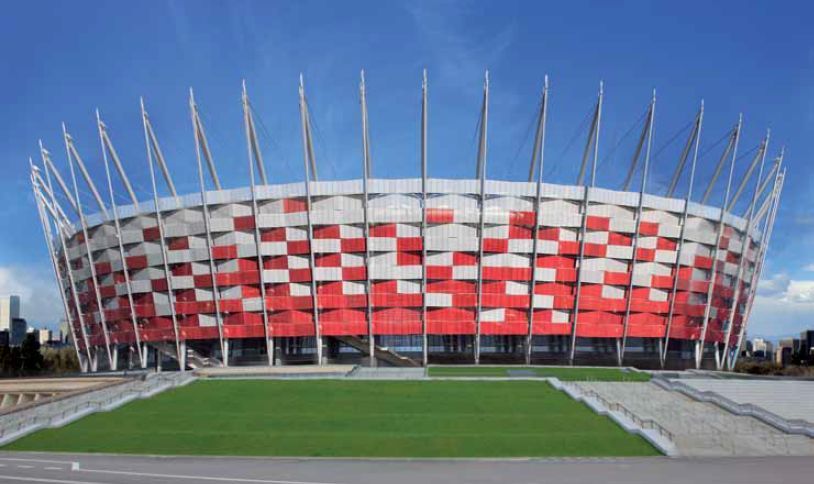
[{"x1": 0, "y1": 452, "x2": 814, "y2": 484}]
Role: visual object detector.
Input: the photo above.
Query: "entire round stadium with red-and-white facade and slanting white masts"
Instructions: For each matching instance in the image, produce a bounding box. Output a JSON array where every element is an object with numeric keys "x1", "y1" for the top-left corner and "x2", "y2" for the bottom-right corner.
[{"x1": 31, "y1": 75, "x2": 785, "y2": 371}]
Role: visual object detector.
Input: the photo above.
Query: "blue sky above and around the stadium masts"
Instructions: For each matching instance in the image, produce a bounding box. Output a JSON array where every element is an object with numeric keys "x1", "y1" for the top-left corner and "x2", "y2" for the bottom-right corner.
[{"x1": 0, "y1": 1, "x2": 814, "y2": 337}]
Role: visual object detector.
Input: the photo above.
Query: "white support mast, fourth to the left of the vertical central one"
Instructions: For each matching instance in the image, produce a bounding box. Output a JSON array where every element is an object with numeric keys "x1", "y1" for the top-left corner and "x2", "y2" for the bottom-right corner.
[{"x1": 189, "y1": 88, "x2": 228, "y2": 367}]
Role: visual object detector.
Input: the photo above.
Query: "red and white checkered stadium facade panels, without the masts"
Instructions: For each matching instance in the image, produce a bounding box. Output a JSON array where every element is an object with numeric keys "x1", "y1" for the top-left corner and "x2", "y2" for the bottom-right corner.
[{"x1": 54, "y1": 179, "x2": 761, "y2": 360}]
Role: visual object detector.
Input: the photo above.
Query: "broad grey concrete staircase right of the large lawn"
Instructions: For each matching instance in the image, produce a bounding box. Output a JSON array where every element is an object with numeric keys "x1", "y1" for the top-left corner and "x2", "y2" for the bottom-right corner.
[{"x1": 575, "y1": 382, "x2": 814, "y2": 457}]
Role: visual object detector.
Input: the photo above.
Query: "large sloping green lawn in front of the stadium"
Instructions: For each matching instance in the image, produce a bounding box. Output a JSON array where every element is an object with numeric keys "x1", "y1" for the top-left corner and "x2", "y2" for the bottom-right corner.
[{"x1": 3, "y1": 380, "x2": 658, "y2": 457}]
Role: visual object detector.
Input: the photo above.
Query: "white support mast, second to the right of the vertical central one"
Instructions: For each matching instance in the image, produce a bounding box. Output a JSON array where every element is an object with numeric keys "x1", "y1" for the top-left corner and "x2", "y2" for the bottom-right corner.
[{"x1": 526, "y1": 76, "x2": 548, "y2": 365}]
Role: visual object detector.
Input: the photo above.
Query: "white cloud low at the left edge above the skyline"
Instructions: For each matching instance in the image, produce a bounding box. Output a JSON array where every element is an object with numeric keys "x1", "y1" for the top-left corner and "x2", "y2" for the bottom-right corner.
[{"x1": 0, "y1": 266, "x2": 65, "y2": 328}]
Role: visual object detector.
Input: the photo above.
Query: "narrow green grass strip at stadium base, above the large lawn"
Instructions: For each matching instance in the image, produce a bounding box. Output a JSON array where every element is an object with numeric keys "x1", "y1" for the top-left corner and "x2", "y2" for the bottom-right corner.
[{"x1": 429, "y1": 366, "x2": 650, "y2": 381}]
